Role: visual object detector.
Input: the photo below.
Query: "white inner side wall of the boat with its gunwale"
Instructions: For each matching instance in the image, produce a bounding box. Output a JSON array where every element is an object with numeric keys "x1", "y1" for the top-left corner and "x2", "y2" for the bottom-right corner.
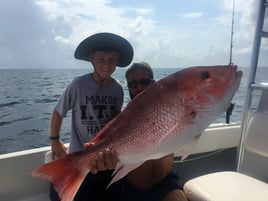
[{"x1": 0, "y1": 124, "x2": 240, "y2": 201}]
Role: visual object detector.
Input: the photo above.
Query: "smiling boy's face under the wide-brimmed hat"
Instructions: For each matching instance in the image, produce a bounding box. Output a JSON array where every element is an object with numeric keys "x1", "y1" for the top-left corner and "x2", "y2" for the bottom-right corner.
[{"x1": 91, "y1": 51, "x2": 119, "y2": 79}]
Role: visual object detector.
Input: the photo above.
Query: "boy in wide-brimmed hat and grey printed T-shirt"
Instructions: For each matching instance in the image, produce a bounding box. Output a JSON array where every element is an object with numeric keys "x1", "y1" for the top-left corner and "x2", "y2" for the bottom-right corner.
[{"x1": 50, "y1": 33, "x2": 133, "y2": 201}]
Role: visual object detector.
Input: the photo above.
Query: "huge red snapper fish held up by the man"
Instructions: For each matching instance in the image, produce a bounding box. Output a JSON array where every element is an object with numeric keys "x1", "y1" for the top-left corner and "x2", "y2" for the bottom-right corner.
[{"x1": 32, "y1": 65, "x2": 242, "y2": 201}]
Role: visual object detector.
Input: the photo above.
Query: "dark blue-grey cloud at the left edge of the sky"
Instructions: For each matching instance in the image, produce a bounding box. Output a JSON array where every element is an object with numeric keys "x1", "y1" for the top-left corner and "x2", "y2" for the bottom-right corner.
[{"x1": 0, "y1": 0, "x2": 73, "y2": 68}]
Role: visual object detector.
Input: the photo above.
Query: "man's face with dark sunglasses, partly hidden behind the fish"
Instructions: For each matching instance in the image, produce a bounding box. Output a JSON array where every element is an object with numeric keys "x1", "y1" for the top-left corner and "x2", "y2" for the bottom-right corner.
[{"x1": 127, "y1": 70, "x2": 153, "y2": 99}]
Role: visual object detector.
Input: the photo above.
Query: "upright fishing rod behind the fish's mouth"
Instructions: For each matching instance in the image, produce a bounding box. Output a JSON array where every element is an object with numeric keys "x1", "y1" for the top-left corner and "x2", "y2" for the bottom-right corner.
[{"x1": 225, "y1": 0, "x2": 235, "y2": 124}]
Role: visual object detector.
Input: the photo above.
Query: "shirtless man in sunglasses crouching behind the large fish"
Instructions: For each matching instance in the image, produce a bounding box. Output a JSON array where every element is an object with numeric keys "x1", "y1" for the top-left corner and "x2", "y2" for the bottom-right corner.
[{"x1": 92, "y1": 63, "x2": 187, "y2": 201}]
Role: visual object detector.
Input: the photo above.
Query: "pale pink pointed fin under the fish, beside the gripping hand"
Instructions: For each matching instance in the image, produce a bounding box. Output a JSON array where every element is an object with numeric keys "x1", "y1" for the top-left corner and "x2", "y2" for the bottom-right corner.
[{"x1": 107, "y1": 163, "x2": 142, "y2": 188}]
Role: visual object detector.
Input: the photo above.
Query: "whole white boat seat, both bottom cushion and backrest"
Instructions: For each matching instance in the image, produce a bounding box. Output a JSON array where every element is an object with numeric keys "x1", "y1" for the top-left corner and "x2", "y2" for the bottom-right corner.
[{"x1": 183, "y1": 110, "x2": 268, "y2": 201}]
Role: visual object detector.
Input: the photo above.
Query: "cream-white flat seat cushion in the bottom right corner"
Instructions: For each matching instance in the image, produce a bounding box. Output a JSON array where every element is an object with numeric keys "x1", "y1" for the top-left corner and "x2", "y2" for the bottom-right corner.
[{"x1": 183, "y1": 171, "x2": 268, "y2": 201}]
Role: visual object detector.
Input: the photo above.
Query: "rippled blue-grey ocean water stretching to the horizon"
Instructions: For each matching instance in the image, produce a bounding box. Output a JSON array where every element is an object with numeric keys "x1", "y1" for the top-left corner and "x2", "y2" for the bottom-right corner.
[{"x1": 0, "y1": 68, "x2": 268, "y2": 154}]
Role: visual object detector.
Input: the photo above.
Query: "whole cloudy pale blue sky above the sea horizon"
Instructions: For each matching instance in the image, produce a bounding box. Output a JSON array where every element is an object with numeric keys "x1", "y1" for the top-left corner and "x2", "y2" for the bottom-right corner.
[{"x1": 0, "y1": 0, "x2": 268, "y2": 69}]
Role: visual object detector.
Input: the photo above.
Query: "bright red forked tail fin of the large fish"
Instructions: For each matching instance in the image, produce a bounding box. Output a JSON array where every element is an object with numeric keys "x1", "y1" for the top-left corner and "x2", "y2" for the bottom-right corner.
[{"x1": 31, "y1": 154, "x2": 89, "y2": 201}]
